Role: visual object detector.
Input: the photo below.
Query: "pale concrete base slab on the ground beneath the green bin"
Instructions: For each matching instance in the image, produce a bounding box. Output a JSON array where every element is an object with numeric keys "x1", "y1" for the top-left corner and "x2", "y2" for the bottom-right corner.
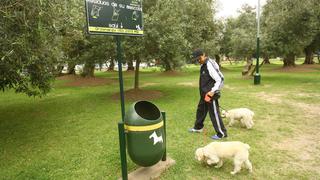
[{"x1": 120, "y1": 157, "x2": 176, "y2": 180}]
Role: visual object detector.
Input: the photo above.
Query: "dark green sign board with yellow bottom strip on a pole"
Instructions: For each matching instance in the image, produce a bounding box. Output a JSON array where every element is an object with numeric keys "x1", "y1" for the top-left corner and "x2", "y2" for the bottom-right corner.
[{"x1": 85, "y1": 0, "x2": 143, "y2": 36}]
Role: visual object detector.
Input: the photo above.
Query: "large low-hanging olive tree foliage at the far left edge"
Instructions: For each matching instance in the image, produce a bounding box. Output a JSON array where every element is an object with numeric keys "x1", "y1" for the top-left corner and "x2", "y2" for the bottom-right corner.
[{"x1": 0, "y1": 0, "x2": 61, "y2": 96}]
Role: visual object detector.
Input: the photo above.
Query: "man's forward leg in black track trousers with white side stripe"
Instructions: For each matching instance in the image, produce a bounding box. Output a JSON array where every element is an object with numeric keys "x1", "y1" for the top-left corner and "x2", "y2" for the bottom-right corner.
[{"x1": 208, "y1": 100, "x2": 228, "y2": 138}]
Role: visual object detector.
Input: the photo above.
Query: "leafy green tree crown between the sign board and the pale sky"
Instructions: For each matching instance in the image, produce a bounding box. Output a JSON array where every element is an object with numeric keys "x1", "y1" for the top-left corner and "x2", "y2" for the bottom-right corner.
[{"x1": 144, "y1": 0, "x2": 217, "y2": 71}]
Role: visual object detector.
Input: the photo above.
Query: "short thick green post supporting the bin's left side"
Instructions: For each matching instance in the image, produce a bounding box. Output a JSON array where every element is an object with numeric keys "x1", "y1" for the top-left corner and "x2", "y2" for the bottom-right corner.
[{"x1": 118, "y1": 122, "x2": 128, "y2": 180}]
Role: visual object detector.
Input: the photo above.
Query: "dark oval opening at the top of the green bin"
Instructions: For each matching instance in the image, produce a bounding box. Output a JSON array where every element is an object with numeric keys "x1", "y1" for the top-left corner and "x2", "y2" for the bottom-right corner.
[{"x1": 134, "y1": 101, "x2": 160, "y2": 121}]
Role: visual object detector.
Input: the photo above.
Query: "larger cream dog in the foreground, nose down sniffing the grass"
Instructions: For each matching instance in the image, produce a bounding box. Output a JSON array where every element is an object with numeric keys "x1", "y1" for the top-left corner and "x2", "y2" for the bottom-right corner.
[{"x1": 195, "y1": 141, "x2": 252, "y2": 174}]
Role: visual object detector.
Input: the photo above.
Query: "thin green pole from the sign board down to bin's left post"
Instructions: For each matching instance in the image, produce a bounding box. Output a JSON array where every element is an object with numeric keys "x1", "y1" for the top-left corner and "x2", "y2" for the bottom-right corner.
[{"x1": 115, "y1": 36, "x2": 125, "y2": 122}]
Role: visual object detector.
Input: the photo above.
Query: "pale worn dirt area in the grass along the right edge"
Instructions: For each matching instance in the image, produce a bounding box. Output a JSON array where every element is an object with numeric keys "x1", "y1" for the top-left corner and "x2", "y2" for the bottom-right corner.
[{"x1": 256, "y1": 92, "x2": 320, "y2": 172}]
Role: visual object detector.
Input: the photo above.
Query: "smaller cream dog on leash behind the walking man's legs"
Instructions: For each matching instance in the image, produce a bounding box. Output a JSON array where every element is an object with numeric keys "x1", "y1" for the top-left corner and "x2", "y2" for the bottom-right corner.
[{"x1": 221, "y1": 108, "x2": 254, "y2": 129}]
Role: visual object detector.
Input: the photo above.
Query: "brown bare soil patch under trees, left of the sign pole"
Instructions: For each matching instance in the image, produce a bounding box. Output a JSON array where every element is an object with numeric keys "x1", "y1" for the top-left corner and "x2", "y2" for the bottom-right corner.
[{"x1": 57, "y1": 75, "x2": 114, "y2": 87}]
